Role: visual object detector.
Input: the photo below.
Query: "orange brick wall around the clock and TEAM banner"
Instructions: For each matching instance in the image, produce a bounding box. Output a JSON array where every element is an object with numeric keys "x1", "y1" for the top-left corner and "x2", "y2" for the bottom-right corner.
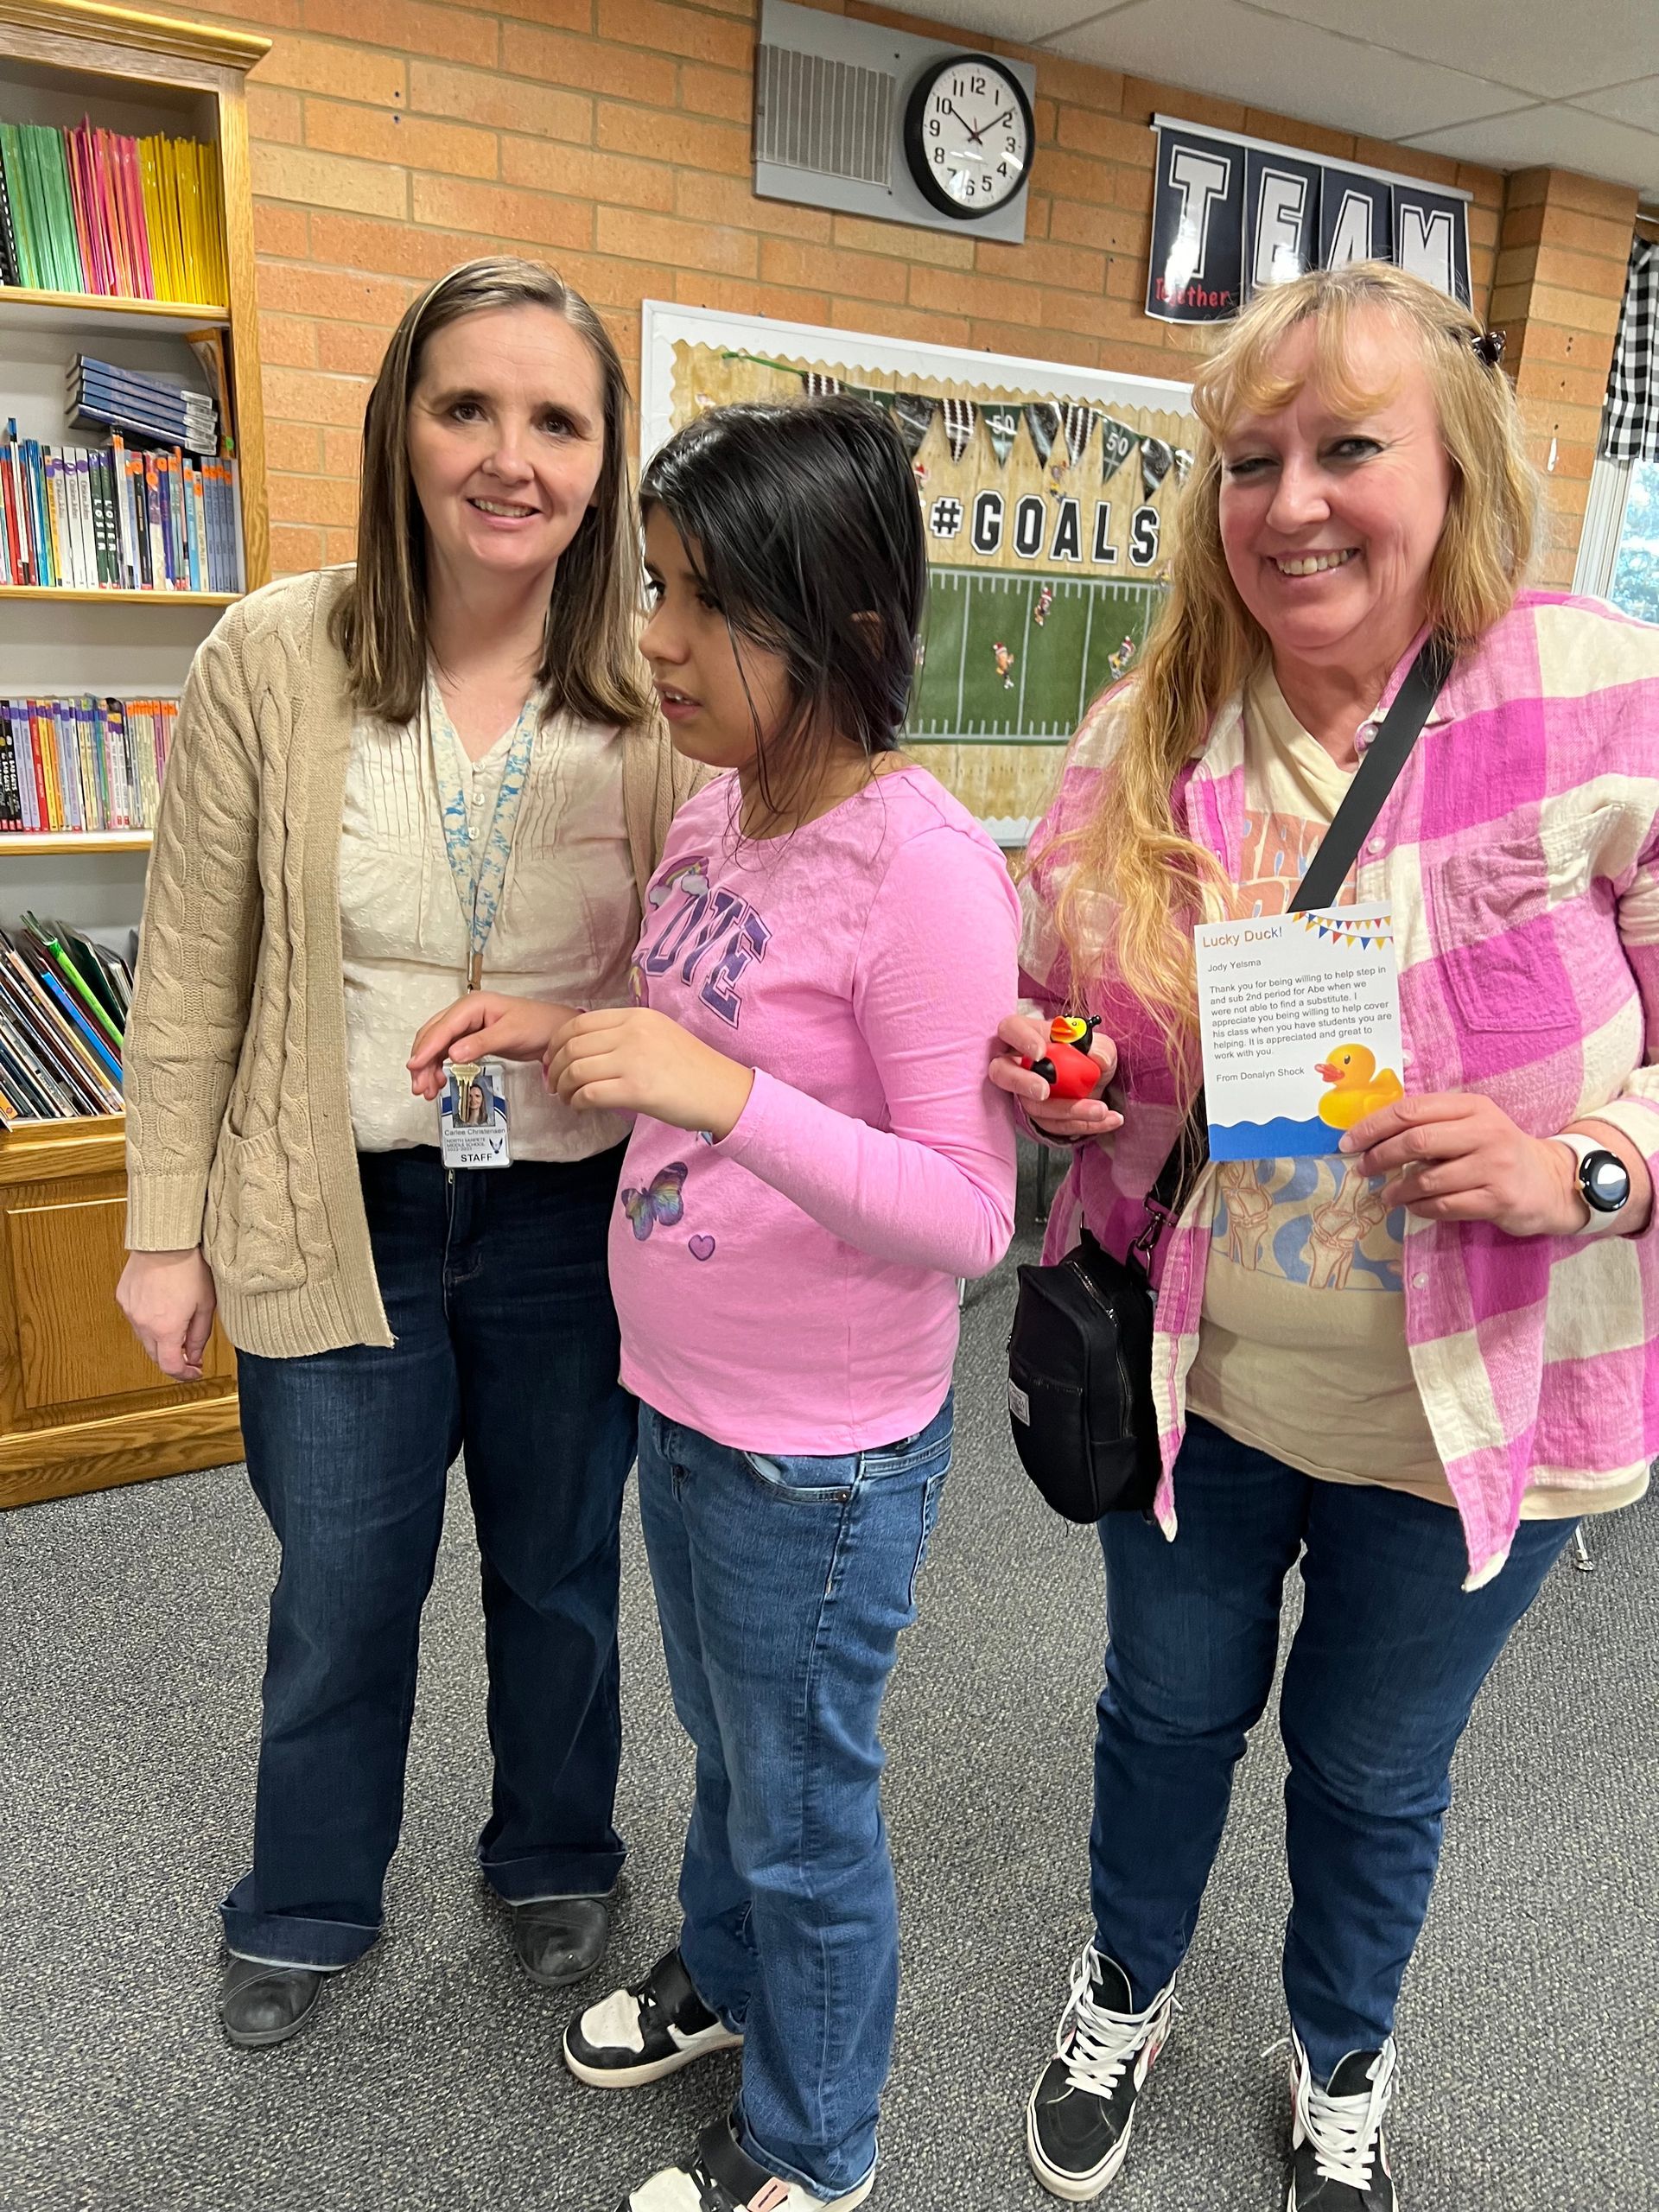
[{"x1": 191, "y1": 0, "x2": 1504, "y2": 573}]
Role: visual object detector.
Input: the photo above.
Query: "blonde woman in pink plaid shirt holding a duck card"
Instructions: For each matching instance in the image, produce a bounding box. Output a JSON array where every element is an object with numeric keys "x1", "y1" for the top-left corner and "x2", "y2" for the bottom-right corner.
[{"x1": 991, "y1": 264, "x2": 1659, "y2": 2212}]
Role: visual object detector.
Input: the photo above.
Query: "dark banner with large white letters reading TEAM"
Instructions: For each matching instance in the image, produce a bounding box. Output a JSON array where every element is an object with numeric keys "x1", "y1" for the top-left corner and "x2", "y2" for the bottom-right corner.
[{"x1": 1146, "y1": 115, "x2": 1469, "y2": 323}]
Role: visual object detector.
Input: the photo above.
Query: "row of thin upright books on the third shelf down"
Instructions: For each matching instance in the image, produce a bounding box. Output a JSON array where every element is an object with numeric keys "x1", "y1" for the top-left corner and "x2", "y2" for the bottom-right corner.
[{"x1": 0, "y1": 695, "x2": 179, "y2": 836}]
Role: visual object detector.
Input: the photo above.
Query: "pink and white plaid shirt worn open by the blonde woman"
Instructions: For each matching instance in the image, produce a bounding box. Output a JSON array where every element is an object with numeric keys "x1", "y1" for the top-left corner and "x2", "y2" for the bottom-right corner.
[{"x1": 1020, "y1": 591, "x2": 1659, "y2": 1588}]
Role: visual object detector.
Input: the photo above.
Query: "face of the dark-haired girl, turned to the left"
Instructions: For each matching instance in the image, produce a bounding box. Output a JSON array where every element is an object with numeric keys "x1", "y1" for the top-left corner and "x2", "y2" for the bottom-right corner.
[{"x1": 639, "y1": 506, "x2": 791, "y2": 767}]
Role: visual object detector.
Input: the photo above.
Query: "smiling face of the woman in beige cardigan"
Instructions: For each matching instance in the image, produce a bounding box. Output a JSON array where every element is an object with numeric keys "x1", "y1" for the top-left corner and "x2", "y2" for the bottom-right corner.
[{"x1": 407, "y1": 305, "x2": 604, "y2": 586}]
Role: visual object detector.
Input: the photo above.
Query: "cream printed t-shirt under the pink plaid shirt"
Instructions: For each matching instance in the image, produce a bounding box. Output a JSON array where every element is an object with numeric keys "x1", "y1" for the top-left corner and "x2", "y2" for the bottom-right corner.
[{"x1": 1185, "y1": 671, "x2": 1624, "y2": 1520}]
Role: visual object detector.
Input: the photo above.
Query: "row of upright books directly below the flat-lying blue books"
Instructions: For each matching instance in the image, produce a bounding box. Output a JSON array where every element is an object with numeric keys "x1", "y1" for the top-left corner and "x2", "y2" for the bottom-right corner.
[{"x1": 0, "y1": 423, "x2": 245, "y2": 591}]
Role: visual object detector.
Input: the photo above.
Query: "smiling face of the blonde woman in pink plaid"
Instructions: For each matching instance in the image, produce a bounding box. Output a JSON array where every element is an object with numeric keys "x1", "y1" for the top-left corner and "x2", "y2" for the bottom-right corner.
[{"x1": 1221, "y1": 312, "x2": 1453, "y2": 668}]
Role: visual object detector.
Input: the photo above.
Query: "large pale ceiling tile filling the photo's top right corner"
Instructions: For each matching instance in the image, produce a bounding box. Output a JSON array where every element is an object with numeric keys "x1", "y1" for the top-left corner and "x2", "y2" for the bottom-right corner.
[{"x1": 1255, "y1": 0, "x2": 1655, "y2": 113}]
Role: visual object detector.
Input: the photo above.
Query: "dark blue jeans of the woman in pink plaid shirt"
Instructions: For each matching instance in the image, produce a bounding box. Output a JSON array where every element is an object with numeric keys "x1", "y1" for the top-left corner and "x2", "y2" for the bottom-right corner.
[{"x1": 1090, "y1": 1421, "x2": 1575, "y2": 2082}]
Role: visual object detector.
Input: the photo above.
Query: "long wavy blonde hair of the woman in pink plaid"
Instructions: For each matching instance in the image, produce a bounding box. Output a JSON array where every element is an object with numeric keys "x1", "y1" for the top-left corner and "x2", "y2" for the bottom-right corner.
[{"x1": 1052, "y1": 261, "x2": 1541, "y2": 1075}]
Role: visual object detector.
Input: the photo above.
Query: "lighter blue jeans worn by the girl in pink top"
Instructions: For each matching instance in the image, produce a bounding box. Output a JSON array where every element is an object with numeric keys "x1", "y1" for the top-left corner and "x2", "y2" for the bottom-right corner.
[{"x1": 639, "y1": 1398, "x2": 951, "y2": 2196}]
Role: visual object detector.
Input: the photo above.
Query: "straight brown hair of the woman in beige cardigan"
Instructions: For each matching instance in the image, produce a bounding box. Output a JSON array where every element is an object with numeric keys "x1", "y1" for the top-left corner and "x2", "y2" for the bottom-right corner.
[{"x1": 332, "y1": 254, "x2": 648, "y2": 723}]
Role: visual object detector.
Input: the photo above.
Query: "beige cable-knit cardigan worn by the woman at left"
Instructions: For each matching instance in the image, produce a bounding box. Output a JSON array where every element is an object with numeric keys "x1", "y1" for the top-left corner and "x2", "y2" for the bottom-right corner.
[{"x1": 124, "y1": 569, "x2": 703, "y2": 1358}]
